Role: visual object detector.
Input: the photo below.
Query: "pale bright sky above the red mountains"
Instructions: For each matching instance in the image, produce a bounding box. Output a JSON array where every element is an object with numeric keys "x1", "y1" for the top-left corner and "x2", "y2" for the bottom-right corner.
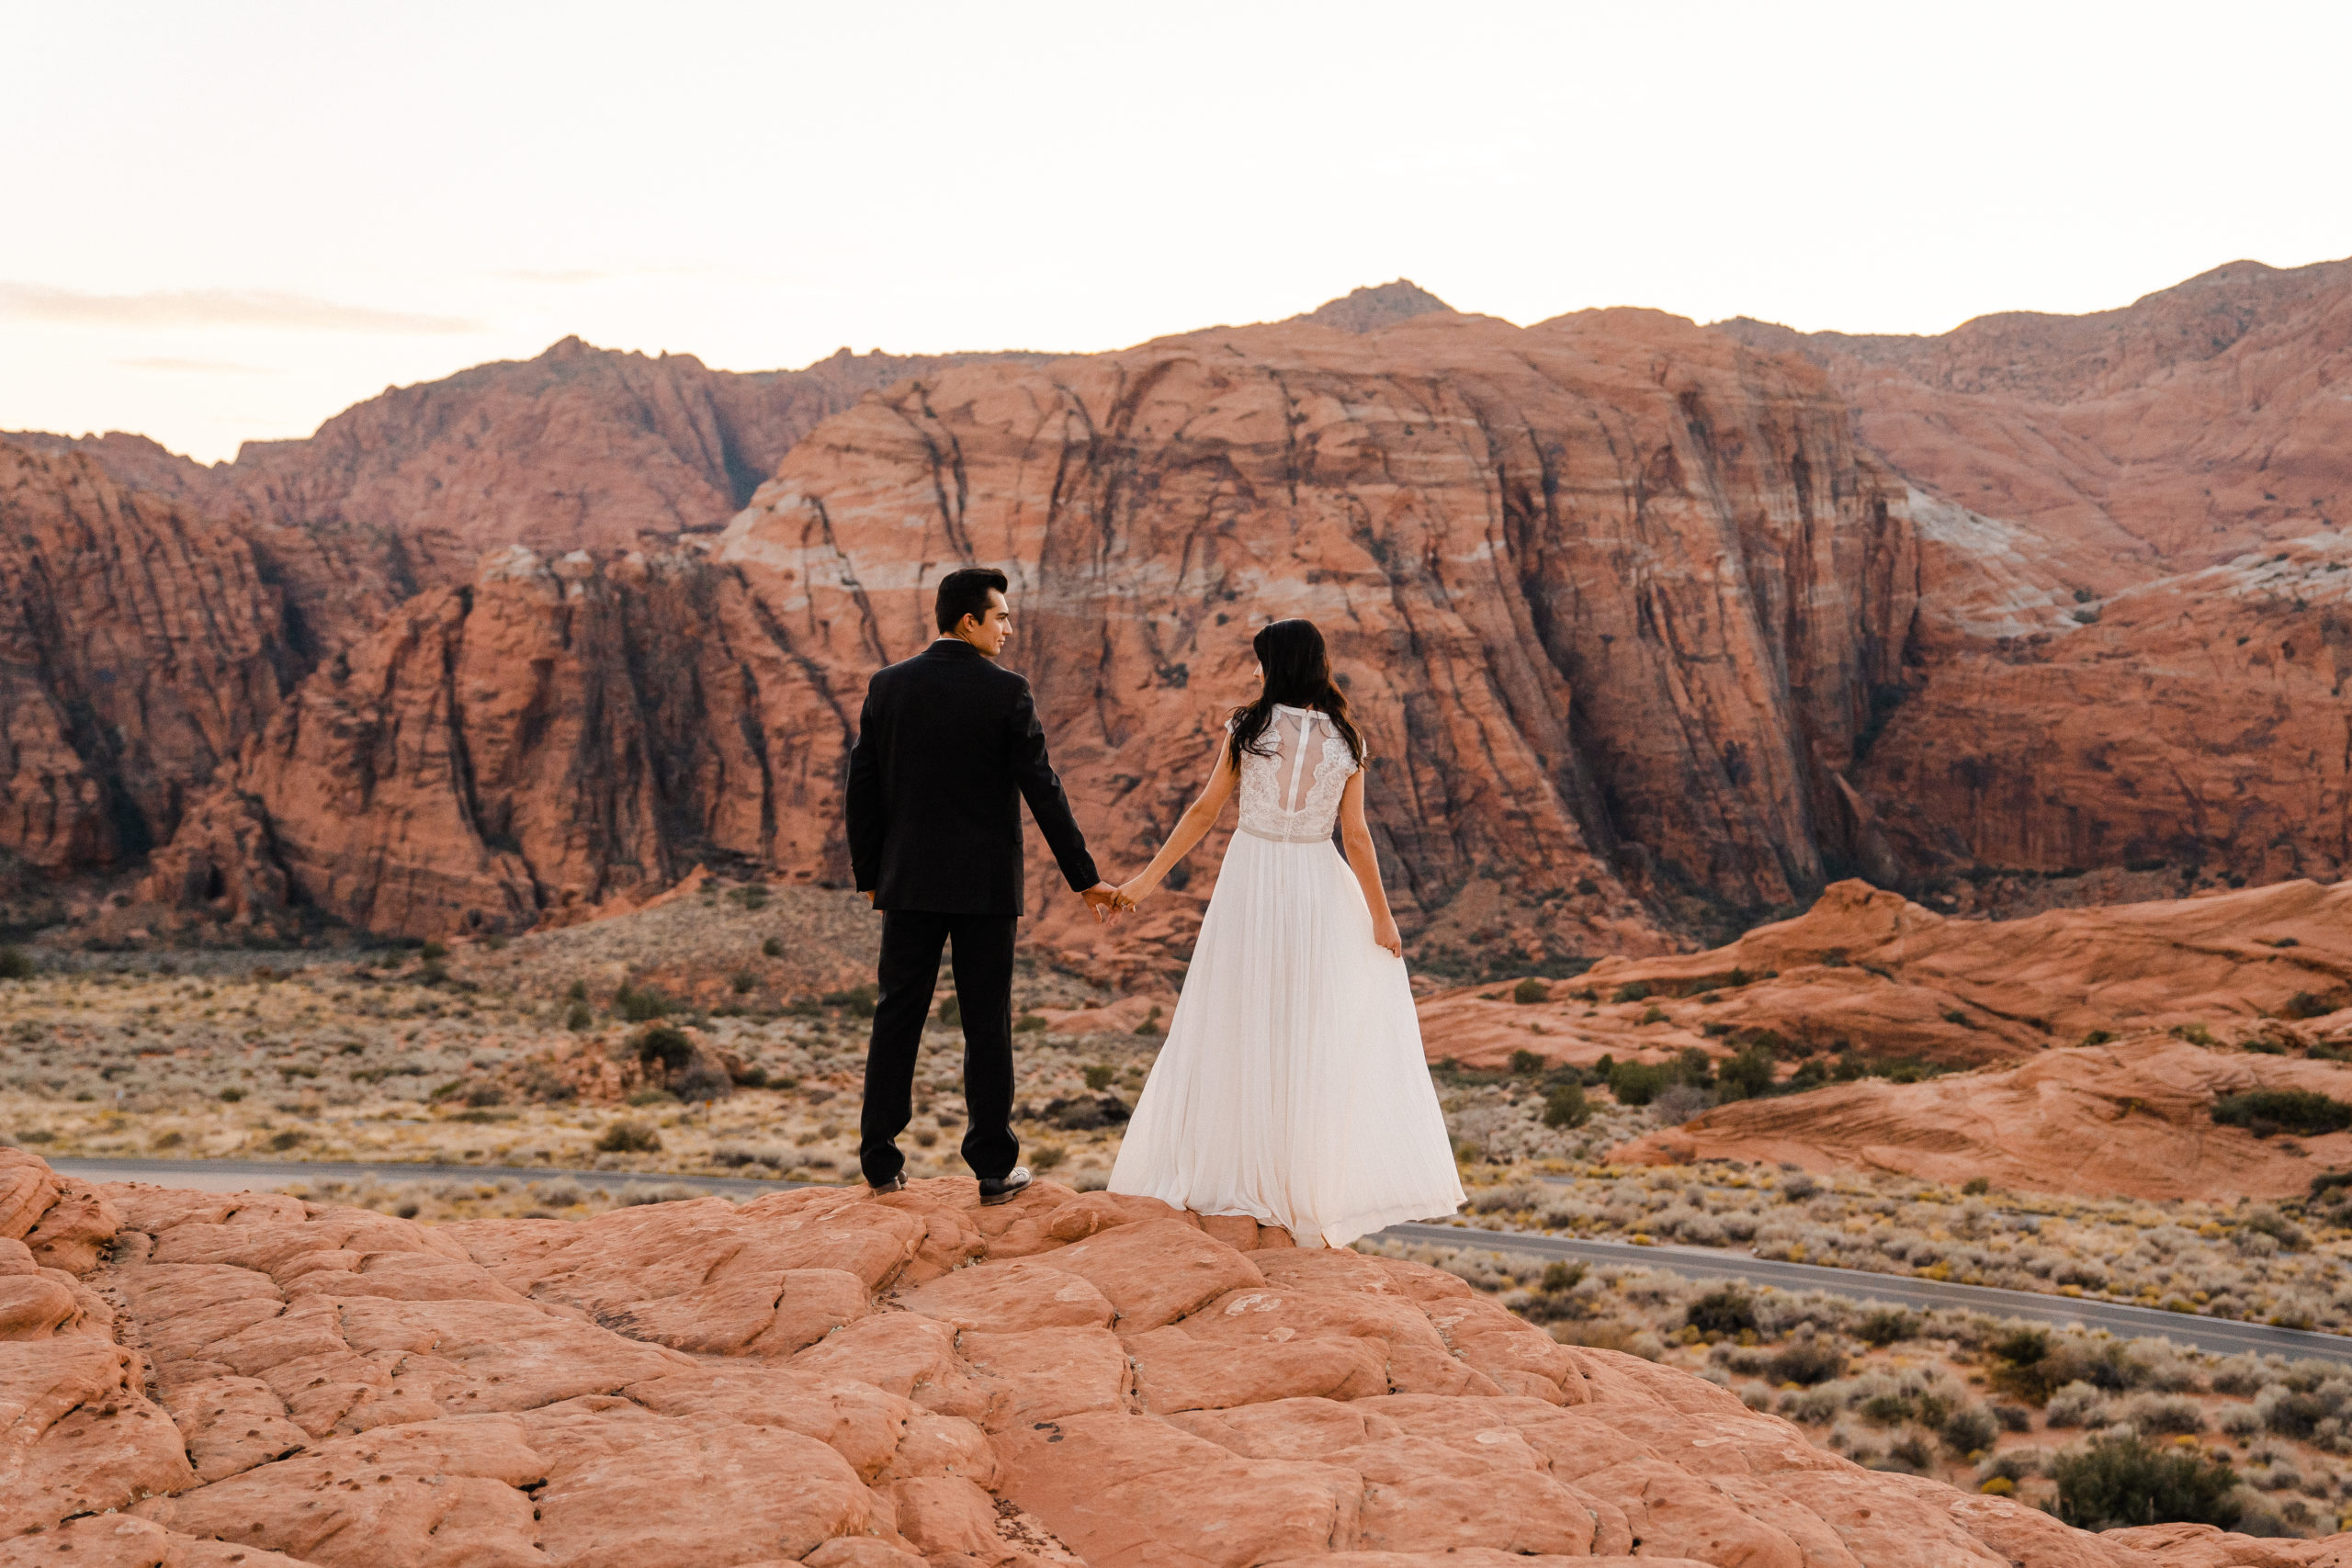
[{"x1": 0, "y1": 0, "x2": 2352, "y2": 461}]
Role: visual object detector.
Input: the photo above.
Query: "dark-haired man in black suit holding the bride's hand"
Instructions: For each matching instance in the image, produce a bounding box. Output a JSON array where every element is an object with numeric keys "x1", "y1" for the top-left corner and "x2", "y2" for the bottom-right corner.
[{"x1": 849, "y1": 567, "x2": 1120, "y2": 1203}]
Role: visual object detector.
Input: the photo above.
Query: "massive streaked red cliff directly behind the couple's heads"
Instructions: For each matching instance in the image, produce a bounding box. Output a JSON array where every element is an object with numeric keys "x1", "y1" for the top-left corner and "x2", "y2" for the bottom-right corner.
[{"x1": 719, "y1": 310, "x2": 1915, "y2": 950}]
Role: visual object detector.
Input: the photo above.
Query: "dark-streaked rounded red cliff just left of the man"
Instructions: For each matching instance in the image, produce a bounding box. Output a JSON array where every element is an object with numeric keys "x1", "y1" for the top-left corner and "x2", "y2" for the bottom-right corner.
[{"x1": 148, "y1": 547, "x2": 852, "y2": 936}]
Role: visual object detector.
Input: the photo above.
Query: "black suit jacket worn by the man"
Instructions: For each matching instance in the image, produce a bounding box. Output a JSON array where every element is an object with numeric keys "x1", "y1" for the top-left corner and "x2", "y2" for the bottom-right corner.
[{"x1": 849, "y1": 637, "x2": 1101, "y2": 915}]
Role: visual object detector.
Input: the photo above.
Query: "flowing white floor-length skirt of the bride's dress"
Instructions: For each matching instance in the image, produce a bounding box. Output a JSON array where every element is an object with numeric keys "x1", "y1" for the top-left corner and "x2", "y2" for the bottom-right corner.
[{"x1": 1110, "y1": 832, "x2": 1463, "y2": 1246}]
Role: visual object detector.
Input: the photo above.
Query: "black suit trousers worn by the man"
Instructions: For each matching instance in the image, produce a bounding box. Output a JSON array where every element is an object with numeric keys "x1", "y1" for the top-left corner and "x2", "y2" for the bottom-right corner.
[{"x1": 858, "y1": 909, "x2": 1021, "y2": 1185}]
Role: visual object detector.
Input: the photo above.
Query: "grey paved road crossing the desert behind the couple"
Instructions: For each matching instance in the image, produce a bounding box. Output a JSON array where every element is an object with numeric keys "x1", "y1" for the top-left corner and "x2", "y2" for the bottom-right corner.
[{"x1": 50, "y1": 1159, "x2": 2352, "y2": 1366}]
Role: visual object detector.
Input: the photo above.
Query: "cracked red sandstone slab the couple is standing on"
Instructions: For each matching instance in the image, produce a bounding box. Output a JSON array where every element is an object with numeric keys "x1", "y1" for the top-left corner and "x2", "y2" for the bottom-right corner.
[{"x1": 0, "y1": 1152, "x2": 2314, "y2": 1568}]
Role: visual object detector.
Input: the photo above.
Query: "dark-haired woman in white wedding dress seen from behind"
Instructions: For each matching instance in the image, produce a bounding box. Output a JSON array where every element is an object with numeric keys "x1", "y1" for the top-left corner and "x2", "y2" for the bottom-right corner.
[{"x1": 1110, "y1": 621, "x2": 1463, "y2": 1246}]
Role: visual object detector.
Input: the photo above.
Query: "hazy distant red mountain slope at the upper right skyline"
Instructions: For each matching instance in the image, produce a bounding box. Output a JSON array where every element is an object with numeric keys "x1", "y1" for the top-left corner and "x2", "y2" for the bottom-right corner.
[{"x1": 1719, "y1": 261, "x2": 2352, "y2": 576}]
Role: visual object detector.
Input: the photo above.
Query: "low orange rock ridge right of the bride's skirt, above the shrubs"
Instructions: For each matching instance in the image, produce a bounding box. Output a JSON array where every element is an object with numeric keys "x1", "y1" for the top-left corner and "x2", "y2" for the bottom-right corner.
[{"x1": 1420, "y1": 882, "x2": 2352, "y2": 1081}]
